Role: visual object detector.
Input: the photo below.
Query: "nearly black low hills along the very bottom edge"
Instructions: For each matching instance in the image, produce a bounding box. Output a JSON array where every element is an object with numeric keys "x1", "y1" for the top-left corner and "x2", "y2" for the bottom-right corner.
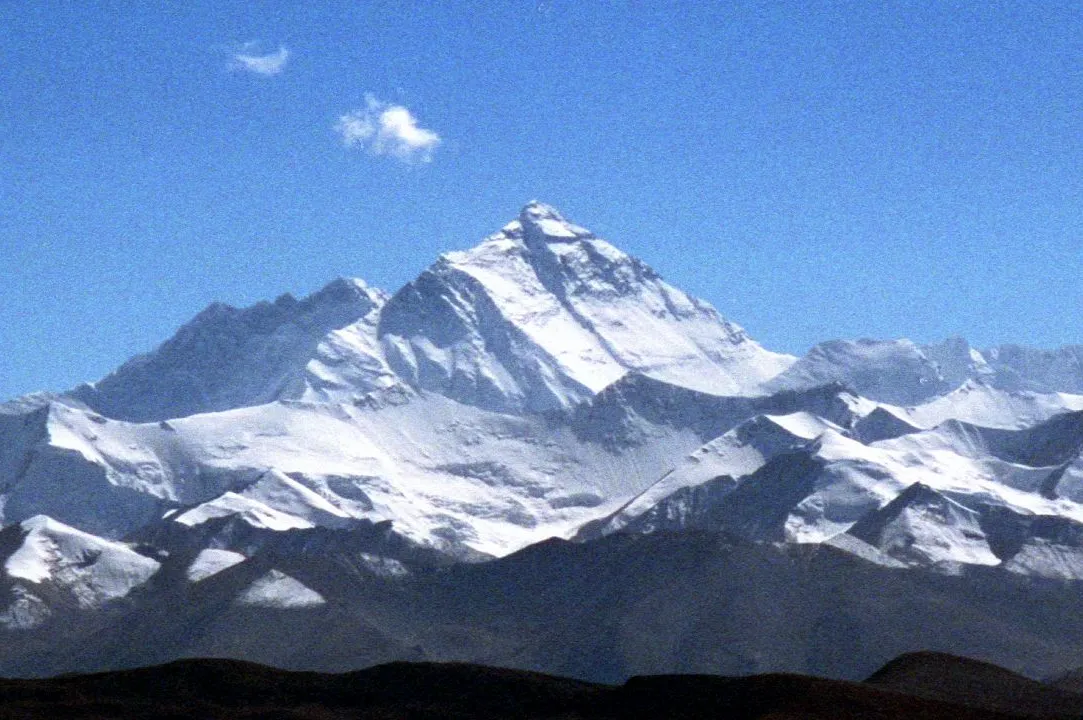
[{"x1": 0, "y1": 654, "x2": 1083, "y2": 720}]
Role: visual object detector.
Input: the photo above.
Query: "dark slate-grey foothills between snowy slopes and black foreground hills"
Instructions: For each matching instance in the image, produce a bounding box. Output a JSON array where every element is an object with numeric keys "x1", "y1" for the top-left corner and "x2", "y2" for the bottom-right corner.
[{"x1": 10, "y1": 533, "x2": 1083, "y2": 684}]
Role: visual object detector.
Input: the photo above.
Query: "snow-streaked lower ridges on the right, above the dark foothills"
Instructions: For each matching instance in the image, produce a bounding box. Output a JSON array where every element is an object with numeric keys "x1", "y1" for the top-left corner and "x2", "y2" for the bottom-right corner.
[{"x1": 585, "y1": 414, "x2": 1083, "y2": 564}]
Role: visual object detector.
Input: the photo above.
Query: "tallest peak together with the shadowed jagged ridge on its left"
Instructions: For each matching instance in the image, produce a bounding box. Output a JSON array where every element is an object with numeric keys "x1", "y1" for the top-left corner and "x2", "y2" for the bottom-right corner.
[{"x1": 73, "y1": 201, "x2": 794, "y2": 421}]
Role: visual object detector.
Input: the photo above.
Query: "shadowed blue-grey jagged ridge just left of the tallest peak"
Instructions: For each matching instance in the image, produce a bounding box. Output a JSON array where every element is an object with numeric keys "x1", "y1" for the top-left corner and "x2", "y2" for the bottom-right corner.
[{"x1": 71, "y1": 278, "x2": 395, "y2": 421}]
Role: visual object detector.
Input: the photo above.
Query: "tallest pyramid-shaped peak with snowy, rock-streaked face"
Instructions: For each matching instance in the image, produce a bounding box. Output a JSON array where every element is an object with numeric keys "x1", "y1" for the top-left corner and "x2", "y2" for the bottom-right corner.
[{"x1": 379, "y1": 202, "x2": 793, "y2": 411}]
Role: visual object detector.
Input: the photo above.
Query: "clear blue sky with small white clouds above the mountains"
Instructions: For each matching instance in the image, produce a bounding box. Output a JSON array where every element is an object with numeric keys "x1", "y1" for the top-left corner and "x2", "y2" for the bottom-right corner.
[{"x1": 0, "y1": 0, "x2": 1083, "y2": 398}]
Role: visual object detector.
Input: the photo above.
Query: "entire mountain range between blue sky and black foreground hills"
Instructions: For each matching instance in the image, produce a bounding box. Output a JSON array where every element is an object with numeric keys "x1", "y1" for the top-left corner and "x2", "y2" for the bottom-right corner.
[{"x1": 0, "y1": 202, "x2": 1083, "y2": 680}]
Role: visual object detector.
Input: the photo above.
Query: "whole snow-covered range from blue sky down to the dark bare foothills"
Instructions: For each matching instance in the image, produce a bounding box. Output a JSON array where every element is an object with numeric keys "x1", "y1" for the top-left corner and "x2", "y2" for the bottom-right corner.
[{"x1": 6, "y1": 202, "x2": 1083, "y2": 615}]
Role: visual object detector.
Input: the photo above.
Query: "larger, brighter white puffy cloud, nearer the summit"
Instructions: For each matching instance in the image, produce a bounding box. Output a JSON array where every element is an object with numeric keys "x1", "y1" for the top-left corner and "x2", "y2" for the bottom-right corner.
[{"x1": 335, "y1": 94, "x2": 441, "y2": 162}]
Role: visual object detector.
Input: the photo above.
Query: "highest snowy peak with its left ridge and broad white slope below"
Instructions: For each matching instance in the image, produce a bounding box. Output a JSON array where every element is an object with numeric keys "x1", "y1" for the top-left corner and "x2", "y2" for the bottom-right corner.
[{"x1": 0, "y1": 204, "x2": 805, "y2": 555}]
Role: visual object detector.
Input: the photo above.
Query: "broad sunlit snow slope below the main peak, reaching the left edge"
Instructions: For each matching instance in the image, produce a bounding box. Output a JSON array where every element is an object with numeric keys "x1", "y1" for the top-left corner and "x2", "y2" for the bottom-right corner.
[{"x1": 4, "y1": 385, "x2": 745, "y2": 555}]
